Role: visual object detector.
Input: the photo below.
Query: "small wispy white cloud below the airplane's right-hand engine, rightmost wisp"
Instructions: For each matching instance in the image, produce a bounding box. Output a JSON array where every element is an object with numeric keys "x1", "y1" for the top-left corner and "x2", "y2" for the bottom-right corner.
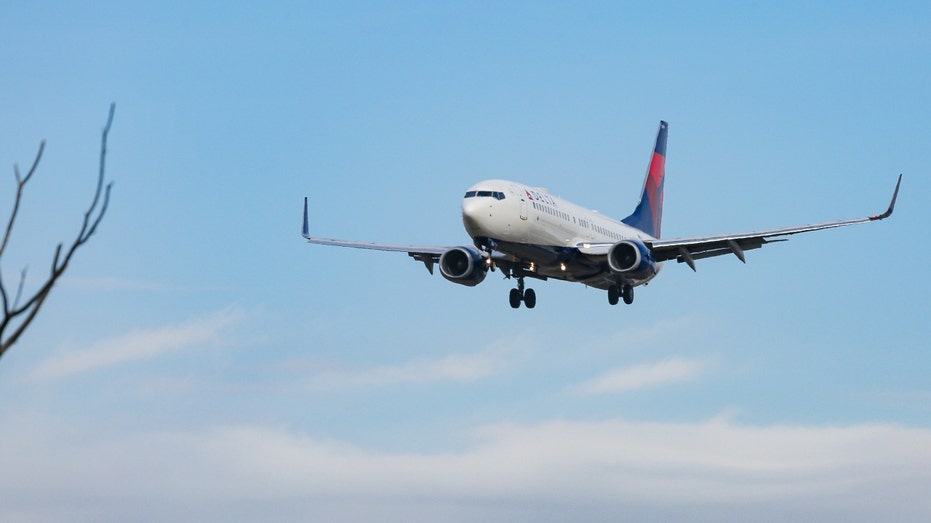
[{"x1": 573, "y1": 358, "x2": 705, "y2": 394}]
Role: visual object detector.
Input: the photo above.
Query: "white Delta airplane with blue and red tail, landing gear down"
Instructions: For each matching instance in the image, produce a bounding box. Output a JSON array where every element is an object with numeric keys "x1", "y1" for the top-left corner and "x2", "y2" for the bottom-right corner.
[{"x1": 302, "y1": 121, "x2": 902, "y2": 309}]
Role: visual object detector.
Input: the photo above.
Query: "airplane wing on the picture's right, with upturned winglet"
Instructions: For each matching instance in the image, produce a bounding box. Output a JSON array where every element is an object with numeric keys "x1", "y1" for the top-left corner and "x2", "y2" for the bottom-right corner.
[{"x1": 645, "y1": 174, "x2": 902, "y2": 271}]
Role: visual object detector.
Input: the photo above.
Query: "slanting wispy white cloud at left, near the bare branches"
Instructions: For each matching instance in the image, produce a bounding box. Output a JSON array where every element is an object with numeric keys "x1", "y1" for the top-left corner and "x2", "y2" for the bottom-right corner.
[{"x1": 27, "y1": 307, "x2": 245, "y2": 380}]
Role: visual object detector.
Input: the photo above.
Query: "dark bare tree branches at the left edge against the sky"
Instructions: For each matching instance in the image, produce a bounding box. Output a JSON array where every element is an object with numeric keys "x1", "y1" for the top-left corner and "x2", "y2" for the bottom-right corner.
[{"x1": 0, "y1": 104, "x2": 116, "y2": 362}]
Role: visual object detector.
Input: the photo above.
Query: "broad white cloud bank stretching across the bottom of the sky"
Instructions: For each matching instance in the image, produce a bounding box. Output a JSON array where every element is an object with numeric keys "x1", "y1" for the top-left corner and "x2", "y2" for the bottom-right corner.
[{"x1": 0, "y1": 419, "x2": 931, "y2": 521}]
